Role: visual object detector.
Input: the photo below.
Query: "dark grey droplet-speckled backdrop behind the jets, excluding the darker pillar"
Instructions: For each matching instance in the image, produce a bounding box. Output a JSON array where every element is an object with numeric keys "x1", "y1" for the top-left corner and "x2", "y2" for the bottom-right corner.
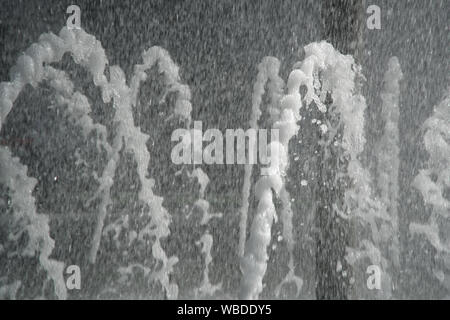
[{"x1": 0, "y1": 0, "x2": 449, "y2": 298}]
